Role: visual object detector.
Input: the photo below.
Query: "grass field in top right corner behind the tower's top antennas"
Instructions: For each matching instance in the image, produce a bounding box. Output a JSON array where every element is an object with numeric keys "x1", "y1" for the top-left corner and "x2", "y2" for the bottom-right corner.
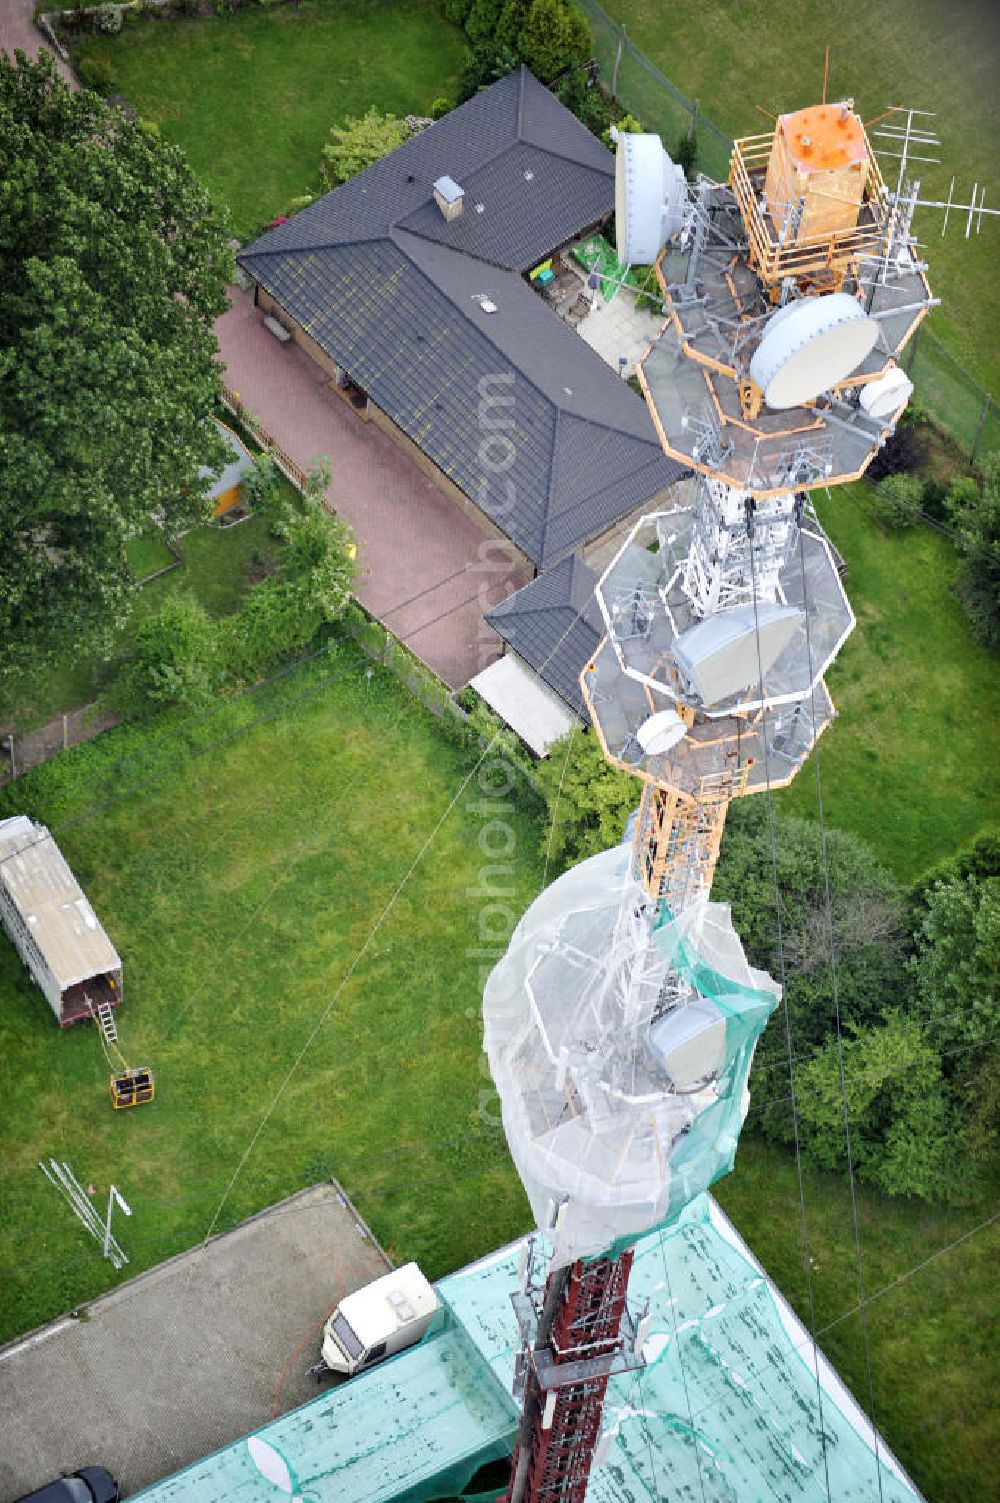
[{"x1": 603, "y1": 0, "x2": 1000, "y2": 397}]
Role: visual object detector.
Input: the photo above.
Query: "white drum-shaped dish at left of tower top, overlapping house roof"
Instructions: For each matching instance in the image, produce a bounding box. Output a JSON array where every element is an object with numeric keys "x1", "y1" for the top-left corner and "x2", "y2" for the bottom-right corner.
[{"x1": 615, "y1": 131, "x2": 687, "y2": 266}]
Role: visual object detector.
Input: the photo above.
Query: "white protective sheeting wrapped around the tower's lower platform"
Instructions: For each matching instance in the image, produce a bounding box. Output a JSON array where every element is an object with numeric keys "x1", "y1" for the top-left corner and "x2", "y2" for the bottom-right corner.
[{"x1": 484, "y1": 848, "x2": 777, "y2": 1264}]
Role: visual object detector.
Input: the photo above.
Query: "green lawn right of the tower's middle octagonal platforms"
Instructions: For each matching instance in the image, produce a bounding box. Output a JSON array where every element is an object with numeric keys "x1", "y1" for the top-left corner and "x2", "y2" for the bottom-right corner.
[{"x1": 776, "y1": 484, "x2": 1000, "y2": 882}]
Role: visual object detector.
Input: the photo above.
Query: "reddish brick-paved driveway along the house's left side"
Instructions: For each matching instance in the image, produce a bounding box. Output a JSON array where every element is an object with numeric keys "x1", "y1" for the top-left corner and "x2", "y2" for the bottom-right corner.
[{"x1": 215, "y1": 289, "x2": 531, "y2": 688}]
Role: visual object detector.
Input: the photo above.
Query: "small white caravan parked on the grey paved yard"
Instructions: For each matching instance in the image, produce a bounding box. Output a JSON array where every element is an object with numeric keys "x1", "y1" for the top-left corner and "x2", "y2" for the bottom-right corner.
[{"x1": 311, "y1": 1263, "x2": 438, "y2": 1377}]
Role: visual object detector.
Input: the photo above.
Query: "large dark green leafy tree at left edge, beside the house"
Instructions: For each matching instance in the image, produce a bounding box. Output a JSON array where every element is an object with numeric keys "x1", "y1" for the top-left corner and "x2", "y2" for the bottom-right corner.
[{"x1": 0, "y1": 53, "x2": 233, "y2": 672}]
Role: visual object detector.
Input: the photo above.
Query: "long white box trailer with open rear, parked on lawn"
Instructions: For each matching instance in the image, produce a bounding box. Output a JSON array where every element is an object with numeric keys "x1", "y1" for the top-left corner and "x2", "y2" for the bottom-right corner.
[{"x1": 0, "y1": 815, "x2": 122, "y2": 1028}]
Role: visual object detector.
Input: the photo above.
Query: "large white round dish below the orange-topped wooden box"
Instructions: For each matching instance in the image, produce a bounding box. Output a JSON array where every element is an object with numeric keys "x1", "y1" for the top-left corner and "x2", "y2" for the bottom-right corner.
[{"x1": 750, "y1": 292, "x2": 878, "y2": 410}]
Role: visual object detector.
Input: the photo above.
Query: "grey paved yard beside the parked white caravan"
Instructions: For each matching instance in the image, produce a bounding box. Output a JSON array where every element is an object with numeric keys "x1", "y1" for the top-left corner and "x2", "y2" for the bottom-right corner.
[{"x1": 0, "y1": 1184, "x2": 389, "y2": 1503}]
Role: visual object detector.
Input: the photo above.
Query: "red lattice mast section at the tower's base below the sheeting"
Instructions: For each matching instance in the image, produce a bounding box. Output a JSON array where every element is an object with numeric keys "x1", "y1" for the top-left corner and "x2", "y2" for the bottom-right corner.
[{"x1": 507, "y1": 1249, "x2": 641, "y2": 1503}]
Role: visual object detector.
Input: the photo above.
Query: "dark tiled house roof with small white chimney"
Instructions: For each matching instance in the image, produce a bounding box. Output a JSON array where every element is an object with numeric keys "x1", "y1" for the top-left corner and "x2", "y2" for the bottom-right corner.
[{"x1": 238, "y1": 68, "x2": 681, "y2": 570}]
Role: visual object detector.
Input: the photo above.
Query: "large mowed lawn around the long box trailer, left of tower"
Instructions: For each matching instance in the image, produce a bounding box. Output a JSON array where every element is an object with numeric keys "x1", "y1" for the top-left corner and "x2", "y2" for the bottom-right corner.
[{"x1": 0, "y1": 648, "x2": 540, "y2": 1335}]
